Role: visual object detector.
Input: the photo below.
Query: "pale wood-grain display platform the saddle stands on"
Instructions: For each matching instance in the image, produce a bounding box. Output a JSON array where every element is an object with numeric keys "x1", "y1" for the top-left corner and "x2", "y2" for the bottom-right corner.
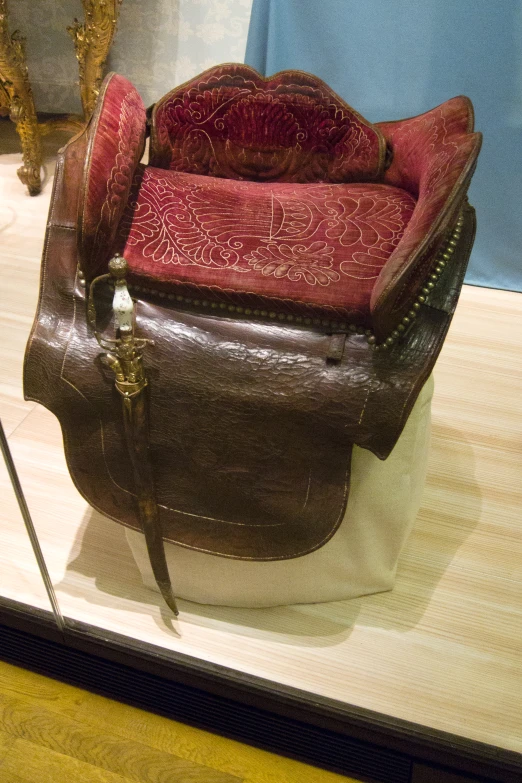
[{"x1": 0, "y1": 122, "x2": 522, "y2": 751}]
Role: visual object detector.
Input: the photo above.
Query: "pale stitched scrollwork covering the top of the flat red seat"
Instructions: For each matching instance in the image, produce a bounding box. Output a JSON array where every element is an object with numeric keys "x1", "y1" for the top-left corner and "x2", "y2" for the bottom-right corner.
[{"x1": 123, "y1": 172, "x2": 415, "y2": 294}]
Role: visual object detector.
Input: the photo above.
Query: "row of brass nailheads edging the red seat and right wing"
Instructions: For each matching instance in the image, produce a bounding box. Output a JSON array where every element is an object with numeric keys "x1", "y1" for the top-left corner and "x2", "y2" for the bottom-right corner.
[{"x1": 90, "y1": 213, "x2": 464, "y2": 351}]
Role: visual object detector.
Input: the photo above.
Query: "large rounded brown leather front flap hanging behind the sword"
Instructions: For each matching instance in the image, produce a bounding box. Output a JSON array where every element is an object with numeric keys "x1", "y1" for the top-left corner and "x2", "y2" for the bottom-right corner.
[{"x1": 58, "y1": 292, "x2": 374, "y2": 560}]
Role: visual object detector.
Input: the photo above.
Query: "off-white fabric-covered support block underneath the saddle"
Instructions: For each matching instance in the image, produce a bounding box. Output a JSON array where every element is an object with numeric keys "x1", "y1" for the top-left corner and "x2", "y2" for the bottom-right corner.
[{"x1": 126, "y1": 378, "x2": 433, "y2": 607}]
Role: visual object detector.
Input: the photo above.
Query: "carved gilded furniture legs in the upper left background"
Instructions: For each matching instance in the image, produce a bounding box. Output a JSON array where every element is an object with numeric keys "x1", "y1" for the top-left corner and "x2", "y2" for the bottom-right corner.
[{"x1": 0, "y1": 0, "x2": 123, "y2": 196}]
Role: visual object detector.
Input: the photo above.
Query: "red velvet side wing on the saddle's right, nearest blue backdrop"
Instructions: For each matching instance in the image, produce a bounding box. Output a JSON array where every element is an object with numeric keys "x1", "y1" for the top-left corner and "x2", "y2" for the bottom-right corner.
[{"x1": 371, "y1": 95, "x2": 482, "y2": 333}]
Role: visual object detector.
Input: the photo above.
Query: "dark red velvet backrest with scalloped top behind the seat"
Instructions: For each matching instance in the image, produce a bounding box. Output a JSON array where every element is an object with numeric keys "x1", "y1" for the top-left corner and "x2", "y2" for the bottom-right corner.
[{"x1": 150, "y1": 63, "x2": 386, "y2": 182}]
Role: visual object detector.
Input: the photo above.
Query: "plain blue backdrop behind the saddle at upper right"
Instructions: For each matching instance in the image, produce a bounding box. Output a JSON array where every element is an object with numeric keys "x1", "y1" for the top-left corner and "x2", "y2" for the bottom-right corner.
[{"x1": 245, "y1": 0, "x2": 522, "y2": 291}]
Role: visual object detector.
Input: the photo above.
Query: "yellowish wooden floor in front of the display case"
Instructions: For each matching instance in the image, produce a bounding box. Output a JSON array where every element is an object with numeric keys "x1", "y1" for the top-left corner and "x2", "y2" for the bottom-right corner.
[{"x1": 0, "y1": 662, "x2": 349, "y2": 783}]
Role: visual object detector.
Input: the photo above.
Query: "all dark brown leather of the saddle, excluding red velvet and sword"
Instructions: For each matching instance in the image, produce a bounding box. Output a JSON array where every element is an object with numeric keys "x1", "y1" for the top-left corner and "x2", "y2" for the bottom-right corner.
[{"x1": 24, "y1": 127, "x2": 475, "y2": 560}]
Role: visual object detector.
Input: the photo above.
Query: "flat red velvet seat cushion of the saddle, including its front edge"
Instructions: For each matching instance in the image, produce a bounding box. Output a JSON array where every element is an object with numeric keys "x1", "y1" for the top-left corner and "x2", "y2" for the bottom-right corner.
[{"x1": 122, "y1": 166, "x2": 415, "y2": 325}]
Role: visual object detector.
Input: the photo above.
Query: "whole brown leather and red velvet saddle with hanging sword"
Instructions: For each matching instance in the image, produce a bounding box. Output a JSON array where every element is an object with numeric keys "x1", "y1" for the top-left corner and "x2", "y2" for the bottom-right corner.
[{"x1": 24, "y1": 64, "x2": 481, "y2": 611}]
